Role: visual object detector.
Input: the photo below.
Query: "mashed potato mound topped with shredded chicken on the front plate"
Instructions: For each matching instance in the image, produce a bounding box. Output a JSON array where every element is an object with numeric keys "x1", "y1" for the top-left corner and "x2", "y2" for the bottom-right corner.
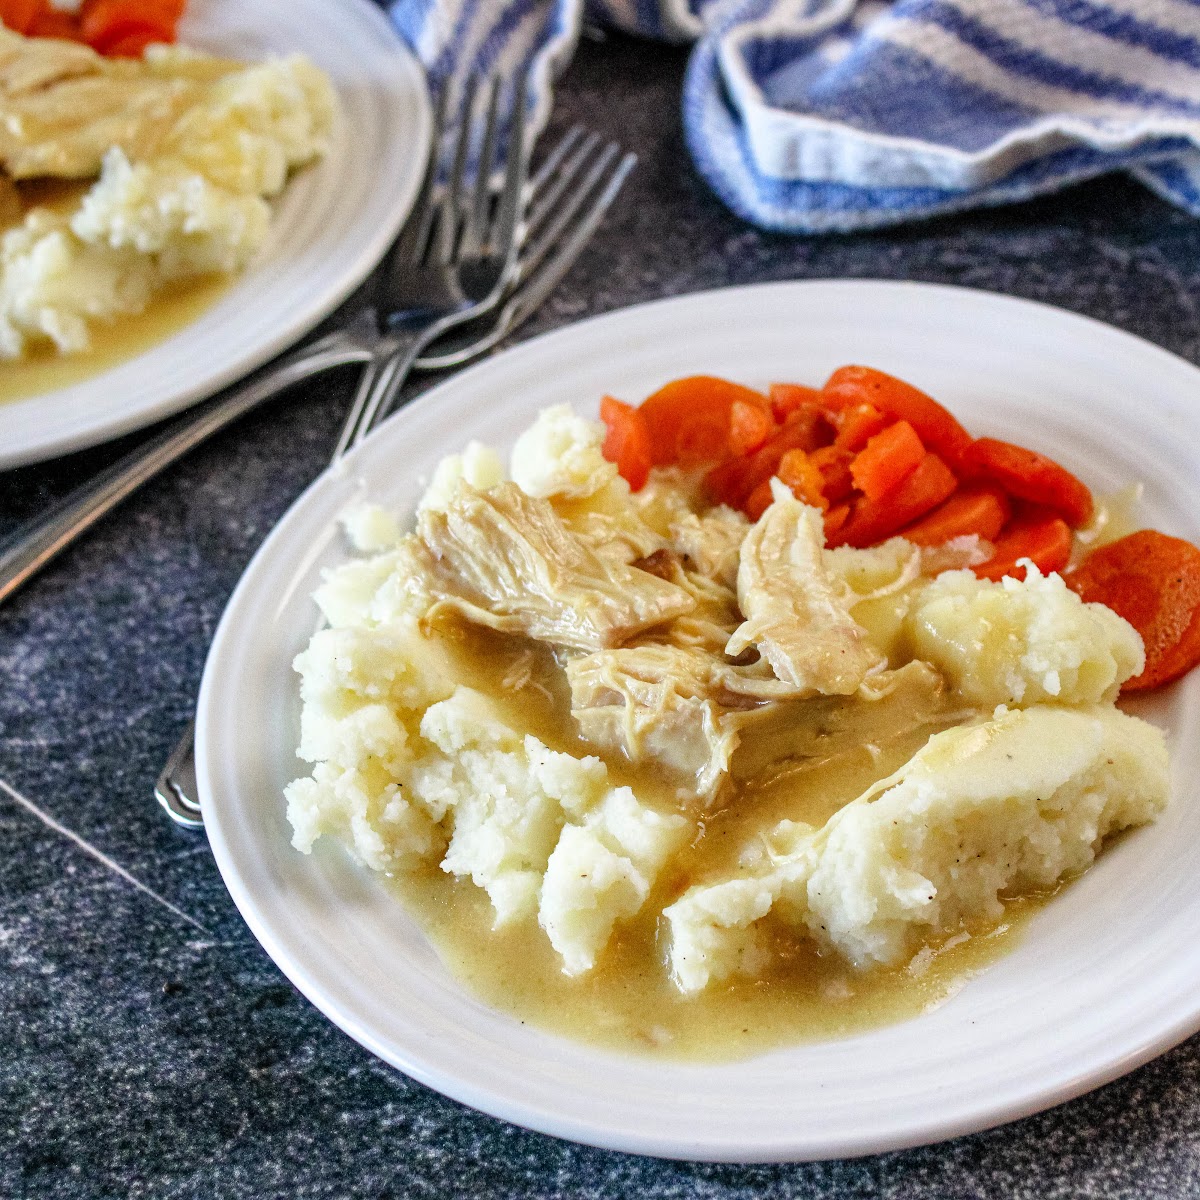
[{"x1": 287, "y1": 406, "x2": 1168, "y2": 995}]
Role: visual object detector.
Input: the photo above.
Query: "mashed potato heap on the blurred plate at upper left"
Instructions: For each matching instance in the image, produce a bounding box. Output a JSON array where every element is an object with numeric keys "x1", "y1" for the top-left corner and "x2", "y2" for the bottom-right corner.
[{"x1": 0, "y1": 48, "x2": 337, "y2": 359}]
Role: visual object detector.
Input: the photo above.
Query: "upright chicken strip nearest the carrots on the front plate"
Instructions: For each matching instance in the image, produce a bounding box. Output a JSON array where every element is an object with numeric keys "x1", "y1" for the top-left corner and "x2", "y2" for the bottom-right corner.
[{"x1": 725, "y1": 480, "x2": 887, "y2": 696}]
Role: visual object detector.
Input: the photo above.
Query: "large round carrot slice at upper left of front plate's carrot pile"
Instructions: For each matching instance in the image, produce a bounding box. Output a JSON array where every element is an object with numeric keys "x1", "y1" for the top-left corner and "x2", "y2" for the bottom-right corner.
[{"x1": 642, "y1": 376, "x2": 767, "y2": 467}]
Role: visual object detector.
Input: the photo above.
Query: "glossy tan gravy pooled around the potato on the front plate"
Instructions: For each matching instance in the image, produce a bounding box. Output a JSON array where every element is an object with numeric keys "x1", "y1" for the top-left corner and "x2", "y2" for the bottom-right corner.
[{"x1": 392, "y1": 626, "x2": 1048, "y2": 1062}]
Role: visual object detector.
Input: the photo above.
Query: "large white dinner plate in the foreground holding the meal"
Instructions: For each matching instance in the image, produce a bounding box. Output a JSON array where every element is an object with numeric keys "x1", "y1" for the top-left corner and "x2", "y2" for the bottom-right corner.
[{"x1": 197, "y1": 282, "x2": 1200, "y2": 1162}]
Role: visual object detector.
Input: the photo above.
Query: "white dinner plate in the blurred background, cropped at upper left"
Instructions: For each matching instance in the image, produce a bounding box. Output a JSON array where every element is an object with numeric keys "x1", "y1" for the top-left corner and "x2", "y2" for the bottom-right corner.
[{"x1": 0, "y1": 0, "x2": 432, "y2": 468}]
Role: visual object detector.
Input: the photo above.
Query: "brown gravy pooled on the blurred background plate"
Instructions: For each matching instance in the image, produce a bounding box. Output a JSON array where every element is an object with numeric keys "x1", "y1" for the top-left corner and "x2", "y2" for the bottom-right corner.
[{"x1": 0, "y1": 180, "x2": 233, "y2": 403}]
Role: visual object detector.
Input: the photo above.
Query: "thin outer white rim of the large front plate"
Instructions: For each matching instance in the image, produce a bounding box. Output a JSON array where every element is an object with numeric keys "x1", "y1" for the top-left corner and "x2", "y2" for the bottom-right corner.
[{"x1": 197, "y1": 278, "x2": 1200, "y2": 1163}]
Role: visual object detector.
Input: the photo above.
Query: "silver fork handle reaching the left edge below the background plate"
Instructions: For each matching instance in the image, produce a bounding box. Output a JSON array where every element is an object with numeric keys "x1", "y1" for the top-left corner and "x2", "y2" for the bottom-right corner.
[{"x1": 0, "y1": 332, "x2": 371, "y2": 604}]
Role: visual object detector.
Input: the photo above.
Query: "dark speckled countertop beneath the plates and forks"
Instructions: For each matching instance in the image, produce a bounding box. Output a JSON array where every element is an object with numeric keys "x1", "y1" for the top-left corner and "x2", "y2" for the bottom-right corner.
[{"x1": 7, "y1": 21, "x2": 1200, "y2": 1200}]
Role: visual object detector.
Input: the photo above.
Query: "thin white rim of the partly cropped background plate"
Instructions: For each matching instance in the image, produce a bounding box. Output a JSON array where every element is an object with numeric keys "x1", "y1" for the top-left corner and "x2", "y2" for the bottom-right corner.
[{"x1": 0, "y1": 0, "x2": 433, "y2": 470}]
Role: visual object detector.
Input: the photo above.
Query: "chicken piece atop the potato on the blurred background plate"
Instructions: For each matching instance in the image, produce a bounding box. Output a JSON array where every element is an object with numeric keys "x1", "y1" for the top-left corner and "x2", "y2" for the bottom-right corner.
[{"x1": 0, "y1": 28, "x2": 241, "y2": 179}]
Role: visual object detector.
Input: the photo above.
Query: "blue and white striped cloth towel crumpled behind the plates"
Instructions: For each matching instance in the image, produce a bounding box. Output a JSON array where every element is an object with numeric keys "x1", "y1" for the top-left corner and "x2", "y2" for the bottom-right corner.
[{"x1": 392, "y1": 0, "x2": 1200, "y2": 233}]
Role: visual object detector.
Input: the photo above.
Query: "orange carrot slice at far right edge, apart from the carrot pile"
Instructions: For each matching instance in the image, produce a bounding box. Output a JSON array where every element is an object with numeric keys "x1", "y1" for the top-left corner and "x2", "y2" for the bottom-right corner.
[{"x1": 1064, "y1": 529, "x2": 1200, "y2": 691}]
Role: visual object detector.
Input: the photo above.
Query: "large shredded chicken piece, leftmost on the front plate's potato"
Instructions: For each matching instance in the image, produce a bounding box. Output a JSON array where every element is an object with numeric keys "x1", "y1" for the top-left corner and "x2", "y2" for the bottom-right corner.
[{"x1": 414, "y1": 484, "x2": 696, "y2": 650}]
